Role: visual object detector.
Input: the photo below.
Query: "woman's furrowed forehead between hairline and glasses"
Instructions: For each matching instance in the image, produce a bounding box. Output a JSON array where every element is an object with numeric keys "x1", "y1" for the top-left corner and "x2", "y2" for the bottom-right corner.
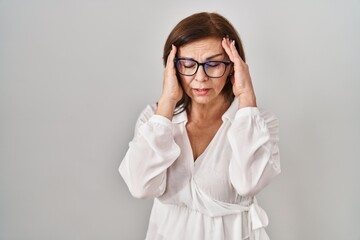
[{"x1": 178, "y1": 38, "x2": 224, "y2": 58}]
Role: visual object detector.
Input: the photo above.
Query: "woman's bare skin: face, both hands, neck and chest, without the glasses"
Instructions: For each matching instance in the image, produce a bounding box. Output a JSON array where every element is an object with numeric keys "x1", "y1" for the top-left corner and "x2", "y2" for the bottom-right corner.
[{"x1": 156, "y1": 38, "x2": 256, "y2": 160}]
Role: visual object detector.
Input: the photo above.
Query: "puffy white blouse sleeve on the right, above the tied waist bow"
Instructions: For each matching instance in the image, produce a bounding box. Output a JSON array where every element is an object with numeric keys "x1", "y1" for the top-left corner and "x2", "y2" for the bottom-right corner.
[{"x1": 228, "y1": 107, "x2": 281, "y2": 196}]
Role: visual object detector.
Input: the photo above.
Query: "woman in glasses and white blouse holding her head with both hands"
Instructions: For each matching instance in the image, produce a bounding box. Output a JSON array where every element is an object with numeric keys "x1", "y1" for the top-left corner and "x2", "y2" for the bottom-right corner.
[{"x1": 119, "y1": 13, "x2": 280, "y2": 240}]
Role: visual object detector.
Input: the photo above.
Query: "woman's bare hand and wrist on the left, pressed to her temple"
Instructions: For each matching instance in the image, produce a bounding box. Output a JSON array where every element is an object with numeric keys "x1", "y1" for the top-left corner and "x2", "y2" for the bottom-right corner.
[{"x1": 156, "y1": 45, "x2": 183, "y2": 120}]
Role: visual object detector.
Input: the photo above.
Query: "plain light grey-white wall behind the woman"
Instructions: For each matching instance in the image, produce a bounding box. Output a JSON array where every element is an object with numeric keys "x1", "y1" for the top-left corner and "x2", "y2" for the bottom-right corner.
[{"x1": 0, "y1": 0, "x2": 360, "y2": 240}]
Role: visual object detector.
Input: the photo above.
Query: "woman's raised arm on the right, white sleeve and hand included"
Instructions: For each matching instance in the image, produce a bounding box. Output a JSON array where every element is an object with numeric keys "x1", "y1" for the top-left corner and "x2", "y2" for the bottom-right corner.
[{"x1": 222, "y1": 38, "x2": 280, "y2": 196}]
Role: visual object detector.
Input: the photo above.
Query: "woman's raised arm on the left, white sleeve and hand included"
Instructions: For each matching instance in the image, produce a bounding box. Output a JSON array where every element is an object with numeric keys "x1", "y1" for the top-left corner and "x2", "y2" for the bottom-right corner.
[{"x1": 119, "y1": 45, "x2": 183, "y2": 198}]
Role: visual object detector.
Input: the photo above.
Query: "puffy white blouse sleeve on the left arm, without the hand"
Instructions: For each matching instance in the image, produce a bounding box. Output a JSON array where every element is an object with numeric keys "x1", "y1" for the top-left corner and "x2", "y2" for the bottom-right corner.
[{"x1": 119, "y1": 106, "x2": 180, "y2": 198}]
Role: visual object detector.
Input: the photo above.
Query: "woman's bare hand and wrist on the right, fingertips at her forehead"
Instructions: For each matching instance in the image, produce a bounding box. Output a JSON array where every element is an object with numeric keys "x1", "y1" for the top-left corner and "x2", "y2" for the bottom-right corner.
[{"x1": 221, "y1": 38, "x2": 256, "y2": 108}]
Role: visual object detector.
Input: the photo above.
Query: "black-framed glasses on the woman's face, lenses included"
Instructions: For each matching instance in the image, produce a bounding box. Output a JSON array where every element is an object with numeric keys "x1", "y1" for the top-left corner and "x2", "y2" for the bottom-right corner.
[{"x1": 174, "y1": 58, "x2": 231, "y2": 78}]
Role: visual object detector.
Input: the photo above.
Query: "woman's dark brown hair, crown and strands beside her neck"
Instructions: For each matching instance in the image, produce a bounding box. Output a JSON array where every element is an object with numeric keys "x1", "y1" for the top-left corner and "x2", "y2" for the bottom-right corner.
[{"x1": 163, "y1": 12, "x2": 245, "y2": 114}]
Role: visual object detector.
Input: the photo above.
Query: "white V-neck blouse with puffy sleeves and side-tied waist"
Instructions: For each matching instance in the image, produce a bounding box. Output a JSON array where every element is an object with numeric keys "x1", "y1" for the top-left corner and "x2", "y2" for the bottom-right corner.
[{"x1": 119, "y1": 101, "x2": 280, "y2": 240}]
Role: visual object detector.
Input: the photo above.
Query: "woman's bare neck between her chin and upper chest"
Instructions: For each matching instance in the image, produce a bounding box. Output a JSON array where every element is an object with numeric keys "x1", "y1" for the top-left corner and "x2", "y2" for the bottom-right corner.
[{"x1": 187, "y1": 95, "x2": 231, "y2": 125}]
